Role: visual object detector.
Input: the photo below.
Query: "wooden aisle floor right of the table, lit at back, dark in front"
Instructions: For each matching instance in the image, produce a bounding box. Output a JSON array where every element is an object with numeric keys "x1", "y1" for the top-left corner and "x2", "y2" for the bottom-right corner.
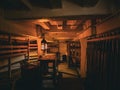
[{"x1": 39, "y1": 63, "x2": 84, "y2": 90}]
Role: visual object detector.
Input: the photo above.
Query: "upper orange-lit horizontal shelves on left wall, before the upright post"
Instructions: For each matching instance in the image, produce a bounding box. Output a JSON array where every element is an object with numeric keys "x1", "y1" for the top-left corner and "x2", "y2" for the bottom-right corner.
[{"x1": 0, "y1": 34, "x2": 27, "y2": 59}]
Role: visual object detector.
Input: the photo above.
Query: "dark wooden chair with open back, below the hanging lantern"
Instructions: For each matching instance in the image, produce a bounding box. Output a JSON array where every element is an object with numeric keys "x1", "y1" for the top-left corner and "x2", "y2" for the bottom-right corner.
[{"x1": 40, "y1": 59, "x2": 57, "y2": 85}]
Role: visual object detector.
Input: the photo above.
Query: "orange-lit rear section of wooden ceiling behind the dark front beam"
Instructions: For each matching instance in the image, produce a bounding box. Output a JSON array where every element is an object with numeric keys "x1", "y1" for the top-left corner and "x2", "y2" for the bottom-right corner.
[{"x1": 12, "y1": 15, "x2": 106, "y2": 41}]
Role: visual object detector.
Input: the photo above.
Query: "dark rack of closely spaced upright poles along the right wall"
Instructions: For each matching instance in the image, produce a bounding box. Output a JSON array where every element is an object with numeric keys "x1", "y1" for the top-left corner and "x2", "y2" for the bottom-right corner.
[{"x1": 86, "y1": 29, "x2": 120, "y2": 90}]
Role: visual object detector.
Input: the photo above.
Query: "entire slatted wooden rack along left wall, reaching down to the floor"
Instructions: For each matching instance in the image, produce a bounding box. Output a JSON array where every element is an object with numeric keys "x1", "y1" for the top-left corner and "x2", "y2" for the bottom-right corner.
[{"x1": 0, "y1": 32, "x2": 38, "y2": 90}]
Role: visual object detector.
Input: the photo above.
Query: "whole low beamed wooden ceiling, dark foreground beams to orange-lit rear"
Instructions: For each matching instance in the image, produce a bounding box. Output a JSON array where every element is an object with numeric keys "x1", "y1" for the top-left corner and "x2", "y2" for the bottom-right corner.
[{"x1": 0, "y1": 0, "x2": 118, "y2": 40}]
